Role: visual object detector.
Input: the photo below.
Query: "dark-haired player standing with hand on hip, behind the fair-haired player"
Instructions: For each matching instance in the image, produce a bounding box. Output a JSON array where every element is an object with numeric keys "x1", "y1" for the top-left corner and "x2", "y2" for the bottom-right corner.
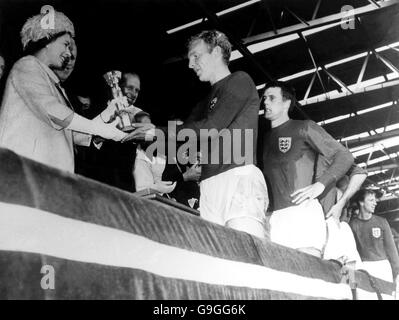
[{"x1": 263, "y1": 81, "x2": 354, "y2": 257}]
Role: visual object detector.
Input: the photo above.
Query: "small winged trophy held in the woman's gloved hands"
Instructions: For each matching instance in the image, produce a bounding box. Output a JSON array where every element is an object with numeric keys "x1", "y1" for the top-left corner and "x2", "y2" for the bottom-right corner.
[{"x1": 104, "y1": 70, "x2": 134, "y2": 131}]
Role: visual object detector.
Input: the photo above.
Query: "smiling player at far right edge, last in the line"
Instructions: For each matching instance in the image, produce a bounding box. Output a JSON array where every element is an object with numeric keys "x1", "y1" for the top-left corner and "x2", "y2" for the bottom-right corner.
[{"x1": 349, "y1": 189, "x2": 399, "y2": 292}]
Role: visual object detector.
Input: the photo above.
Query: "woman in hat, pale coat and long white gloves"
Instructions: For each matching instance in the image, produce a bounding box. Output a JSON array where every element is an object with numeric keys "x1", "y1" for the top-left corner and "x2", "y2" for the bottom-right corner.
[{"x1": 0, "y1": 6, "x2": 126, "y2": 172}]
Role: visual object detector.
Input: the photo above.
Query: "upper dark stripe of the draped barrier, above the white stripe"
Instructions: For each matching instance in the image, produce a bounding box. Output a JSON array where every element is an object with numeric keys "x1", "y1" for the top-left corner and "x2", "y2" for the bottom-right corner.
[{"x1": 0, "y1": 148, "x2": 392, "y2": 294}]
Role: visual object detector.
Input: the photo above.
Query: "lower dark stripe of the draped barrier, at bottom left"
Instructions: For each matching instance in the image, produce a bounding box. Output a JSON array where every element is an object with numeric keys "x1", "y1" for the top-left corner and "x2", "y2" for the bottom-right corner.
[{"x1": 0, "y1": 251, "x2": 324, "y2": 300}]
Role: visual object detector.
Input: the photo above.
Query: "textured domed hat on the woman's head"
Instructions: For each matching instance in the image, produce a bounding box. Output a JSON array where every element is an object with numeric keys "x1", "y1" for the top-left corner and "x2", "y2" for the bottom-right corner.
[{"x1": 21, "y1": 5, "x2": 75, "y2": 49}]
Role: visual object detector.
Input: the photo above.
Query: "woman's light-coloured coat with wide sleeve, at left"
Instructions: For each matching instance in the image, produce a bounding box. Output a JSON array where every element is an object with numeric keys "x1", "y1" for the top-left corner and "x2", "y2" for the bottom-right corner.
[{"x1": 0, "y1": 56, "x2": 91, "y2": 172}]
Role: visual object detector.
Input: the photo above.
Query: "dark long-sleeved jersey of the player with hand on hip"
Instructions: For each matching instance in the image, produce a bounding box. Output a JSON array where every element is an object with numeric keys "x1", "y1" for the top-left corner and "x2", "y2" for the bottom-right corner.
[{"x1": 263, "y1": 120, "x2": 354, "y2": 210}]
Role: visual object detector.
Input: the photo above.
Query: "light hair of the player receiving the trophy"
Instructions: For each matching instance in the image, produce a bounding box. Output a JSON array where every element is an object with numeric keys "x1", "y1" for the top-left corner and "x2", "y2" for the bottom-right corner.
[{"x1": 187, "y1": 30, "x2": 231, "y2": 65}]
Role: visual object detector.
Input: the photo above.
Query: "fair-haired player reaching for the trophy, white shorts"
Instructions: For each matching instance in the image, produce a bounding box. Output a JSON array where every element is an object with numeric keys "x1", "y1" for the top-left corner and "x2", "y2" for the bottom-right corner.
[{"x1": 125, "y1": 30, "x2": 268, "y2": 237}]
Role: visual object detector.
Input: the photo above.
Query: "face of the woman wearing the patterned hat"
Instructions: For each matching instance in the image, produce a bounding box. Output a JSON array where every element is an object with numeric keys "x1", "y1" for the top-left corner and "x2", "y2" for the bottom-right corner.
[{"x1": 44, "y1": 33, "x2": 72, "y2": 69}]
